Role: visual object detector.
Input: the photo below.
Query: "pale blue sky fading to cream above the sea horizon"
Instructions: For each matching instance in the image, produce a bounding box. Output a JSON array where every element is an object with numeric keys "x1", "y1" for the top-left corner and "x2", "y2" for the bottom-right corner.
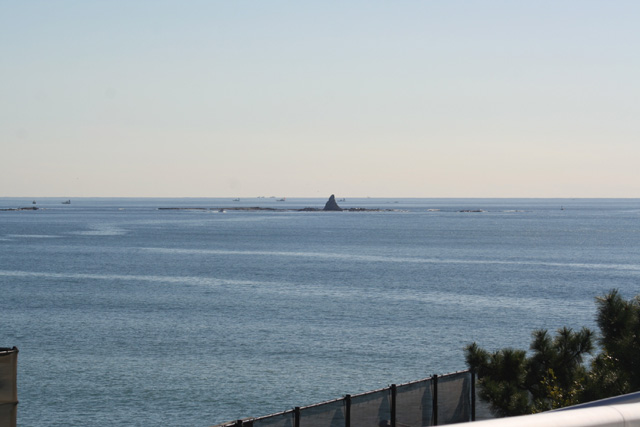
[{"x1": 0, "y1": 0, "x2": 640, "y2": 198}]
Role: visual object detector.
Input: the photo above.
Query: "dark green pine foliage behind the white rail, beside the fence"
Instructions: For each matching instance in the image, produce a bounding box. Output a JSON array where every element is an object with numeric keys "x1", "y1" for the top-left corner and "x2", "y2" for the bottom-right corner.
[{"x1": 465, "y1": 290, "x2": 640, "y2": 416}]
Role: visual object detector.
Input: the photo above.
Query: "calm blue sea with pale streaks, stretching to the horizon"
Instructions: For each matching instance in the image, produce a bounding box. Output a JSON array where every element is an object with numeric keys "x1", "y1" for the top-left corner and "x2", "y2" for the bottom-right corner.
[{"x1": 0, "y1": 199, "x2": 640, "y2": 426}]
